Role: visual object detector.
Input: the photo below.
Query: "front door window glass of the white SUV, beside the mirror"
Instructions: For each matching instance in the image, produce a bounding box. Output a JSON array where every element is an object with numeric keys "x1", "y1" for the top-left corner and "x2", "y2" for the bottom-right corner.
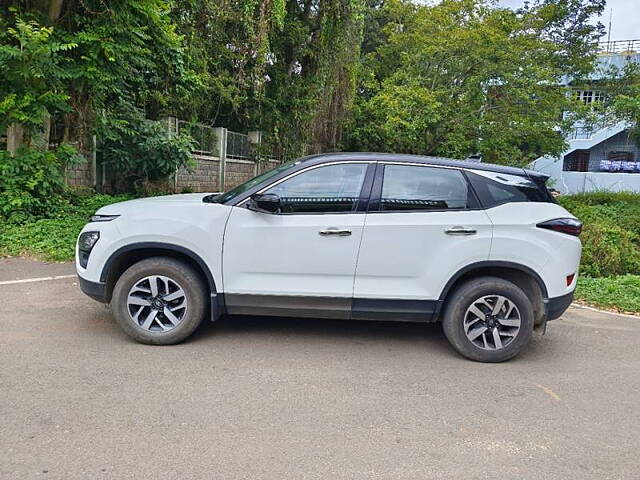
[{"x1": 264, "y1": 163, "x2": 368, "y2": 213}]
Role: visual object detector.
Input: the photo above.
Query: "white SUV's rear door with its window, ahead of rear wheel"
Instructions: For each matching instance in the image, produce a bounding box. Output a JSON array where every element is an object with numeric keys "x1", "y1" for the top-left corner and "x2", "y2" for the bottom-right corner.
[{"x1": 353, "y1": 163, "x2": 492, "y2": 320}]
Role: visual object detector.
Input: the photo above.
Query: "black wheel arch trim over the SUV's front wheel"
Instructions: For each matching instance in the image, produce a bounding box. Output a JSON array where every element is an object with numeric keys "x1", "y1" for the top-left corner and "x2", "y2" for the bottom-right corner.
[{"x1": 100, "y1": 242, "x2": 217, "y2": 302}]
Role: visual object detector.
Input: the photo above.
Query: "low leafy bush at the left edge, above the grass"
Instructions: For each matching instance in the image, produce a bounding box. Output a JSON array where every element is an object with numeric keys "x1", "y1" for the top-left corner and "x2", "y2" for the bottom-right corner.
[{"x1": 0, "y1": 145, "x2": 78, "y2": 222}]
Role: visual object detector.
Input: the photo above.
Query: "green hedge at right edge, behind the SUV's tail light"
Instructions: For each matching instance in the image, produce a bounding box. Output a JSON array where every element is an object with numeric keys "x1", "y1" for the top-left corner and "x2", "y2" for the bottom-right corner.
[{"x1": 559, "y1": 192, "x2": 640, "y2": 277}]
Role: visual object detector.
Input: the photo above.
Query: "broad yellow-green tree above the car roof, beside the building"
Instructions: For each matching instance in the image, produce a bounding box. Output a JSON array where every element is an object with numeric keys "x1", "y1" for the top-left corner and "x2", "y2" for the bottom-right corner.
[{"x1": 346, "y1": 0, "x2": 604, "y2": 165}]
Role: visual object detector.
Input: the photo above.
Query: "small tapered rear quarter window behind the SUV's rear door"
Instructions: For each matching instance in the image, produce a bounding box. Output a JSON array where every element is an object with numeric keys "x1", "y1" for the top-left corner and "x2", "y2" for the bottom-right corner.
[{"x1": 467, "y1": 170, "x2": 553, "y2": 208}]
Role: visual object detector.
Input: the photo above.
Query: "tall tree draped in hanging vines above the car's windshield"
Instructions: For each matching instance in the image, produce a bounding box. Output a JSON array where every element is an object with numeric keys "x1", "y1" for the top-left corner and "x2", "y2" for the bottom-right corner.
[{"x1": 172, "y1": 0, "x2": 364, "y2": 157}]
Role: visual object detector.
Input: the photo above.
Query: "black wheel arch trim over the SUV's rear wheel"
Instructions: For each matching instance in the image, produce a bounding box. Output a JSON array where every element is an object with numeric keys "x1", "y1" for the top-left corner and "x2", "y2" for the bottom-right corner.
[{"x1": 439, "y1": 260, "x2": 549, "y2": 325}]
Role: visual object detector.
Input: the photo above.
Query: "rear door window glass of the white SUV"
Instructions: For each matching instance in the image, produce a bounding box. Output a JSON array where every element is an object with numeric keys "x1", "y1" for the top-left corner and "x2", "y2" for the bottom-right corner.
[{"x1": 380, "y1": 165, "x2": 472, "y2": 210}]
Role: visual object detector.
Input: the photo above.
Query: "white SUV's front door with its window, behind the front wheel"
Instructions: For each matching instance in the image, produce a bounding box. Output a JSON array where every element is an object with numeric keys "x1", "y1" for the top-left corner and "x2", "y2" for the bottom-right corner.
[{"x1": 223, "y1": 162, "x2": 375, "y2": 318}]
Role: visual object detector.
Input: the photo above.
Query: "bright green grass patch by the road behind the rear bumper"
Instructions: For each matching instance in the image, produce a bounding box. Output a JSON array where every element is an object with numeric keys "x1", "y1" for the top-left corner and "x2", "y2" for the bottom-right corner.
[{"x1": 575, "y1": 275, "x2": 640, "y2": 313}]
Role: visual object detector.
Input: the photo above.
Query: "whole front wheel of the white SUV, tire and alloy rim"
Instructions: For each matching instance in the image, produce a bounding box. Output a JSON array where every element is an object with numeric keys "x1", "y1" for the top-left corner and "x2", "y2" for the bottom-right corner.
[{"x1": 111, "y1": 257, "x2": 207, "y2": 345}]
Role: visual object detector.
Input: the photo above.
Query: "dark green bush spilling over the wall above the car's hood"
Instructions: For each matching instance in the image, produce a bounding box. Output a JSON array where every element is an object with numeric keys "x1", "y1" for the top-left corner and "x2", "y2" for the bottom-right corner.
[{"x1": 99, "y1": 119, "x2": 194, "y2": 188}]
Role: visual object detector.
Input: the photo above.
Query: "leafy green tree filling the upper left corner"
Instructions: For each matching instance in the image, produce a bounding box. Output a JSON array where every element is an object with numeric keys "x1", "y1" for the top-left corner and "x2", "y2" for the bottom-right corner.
[{"x1": 0, "y1": 0, "x2": 194, "y2": 151}]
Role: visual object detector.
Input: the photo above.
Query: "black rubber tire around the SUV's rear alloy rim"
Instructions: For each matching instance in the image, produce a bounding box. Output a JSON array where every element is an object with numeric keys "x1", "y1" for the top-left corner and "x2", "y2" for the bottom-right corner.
[{"x1": 442, "y1": 277, "x2": 534, "y2": 363}]
